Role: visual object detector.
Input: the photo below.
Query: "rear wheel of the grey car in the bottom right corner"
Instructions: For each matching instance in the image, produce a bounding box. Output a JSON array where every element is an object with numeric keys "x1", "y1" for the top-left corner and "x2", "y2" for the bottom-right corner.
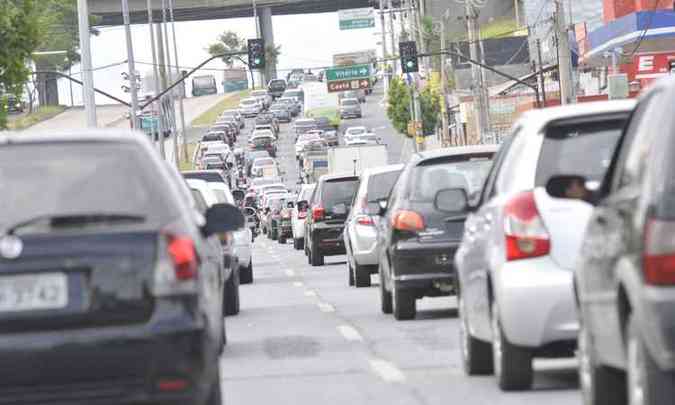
[{"x1": 615, "y1": 315, "x2": 675, "y2": 405}]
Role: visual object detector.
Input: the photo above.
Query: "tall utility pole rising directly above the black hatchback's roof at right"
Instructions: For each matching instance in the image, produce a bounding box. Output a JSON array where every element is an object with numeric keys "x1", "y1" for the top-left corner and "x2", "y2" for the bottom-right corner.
[{"x1": 466, "y1": 1, "x2": 490, "y2": 143}]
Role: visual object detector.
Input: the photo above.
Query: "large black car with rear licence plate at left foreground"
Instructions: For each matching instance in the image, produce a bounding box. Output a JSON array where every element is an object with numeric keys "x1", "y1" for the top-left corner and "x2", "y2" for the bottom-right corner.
[{"x1": 0, "y1": 129, "x2": 244, "y2": 405}]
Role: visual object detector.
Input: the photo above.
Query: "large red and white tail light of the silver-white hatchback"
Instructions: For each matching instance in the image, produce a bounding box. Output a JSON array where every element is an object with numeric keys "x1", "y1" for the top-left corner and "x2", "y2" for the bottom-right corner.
[{"x1": 504, "y1": 191, "x2": 551, "y2": 260}]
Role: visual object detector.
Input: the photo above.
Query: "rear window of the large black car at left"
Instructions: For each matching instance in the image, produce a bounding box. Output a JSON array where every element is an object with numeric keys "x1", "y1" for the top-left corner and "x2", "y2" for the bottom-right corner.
[{"x1": 0, "y1": 142, "x2": 180, "y2": 233}]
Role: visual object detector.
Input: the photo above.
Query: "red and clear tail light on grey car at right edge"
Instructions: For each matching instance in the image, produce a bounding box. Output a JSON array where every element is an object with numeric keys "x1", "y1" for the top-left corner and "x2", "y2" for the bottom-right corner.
[{"x1": 643, "y1": 219, "x2": 675, "y2": 285}]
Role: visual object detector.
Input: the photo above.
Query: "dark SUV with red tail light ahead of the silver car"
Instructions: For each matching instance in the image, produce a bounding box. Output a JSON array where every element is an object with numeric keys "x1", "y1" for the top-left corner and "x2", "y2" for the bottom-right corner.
[{"x1": 298, "y1": 175, "x2": 359, "y2": 266}]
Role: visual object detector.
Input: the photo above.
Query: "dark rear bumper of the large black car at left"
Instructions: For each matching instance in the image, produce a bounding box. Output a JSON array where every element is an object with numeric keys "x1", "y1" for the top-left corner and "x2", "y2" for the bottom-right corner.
[{"x1": 0, "y1": 300, "x2": 214, "y2": 405}]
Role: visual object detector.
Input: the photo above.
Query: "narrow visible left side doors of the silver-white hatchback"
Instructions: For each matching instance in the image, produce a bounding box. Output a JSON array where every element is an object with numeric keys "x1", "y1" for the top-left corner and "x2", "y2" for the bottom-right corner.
[{"x1": 457, "y1": 134, "x2": 520, "y2": 340}]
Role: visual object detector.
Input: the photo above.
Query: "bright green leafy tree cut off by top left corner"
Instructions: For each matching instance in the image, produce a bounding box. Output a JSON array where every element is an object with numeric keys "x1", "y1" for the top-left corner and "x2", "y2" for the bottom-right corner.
[{"x1": 0, "y1": 0, "x2": 41, "y2": 129}]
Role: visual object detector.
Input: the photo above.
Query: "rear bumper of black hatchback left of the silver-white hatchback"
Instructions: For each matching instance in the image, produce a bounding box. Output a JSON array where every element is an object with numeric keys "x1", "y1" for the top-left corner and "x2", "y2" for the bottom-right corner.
[{"x1": 390, "y1": 241, "x2": 458, "y2": 296}]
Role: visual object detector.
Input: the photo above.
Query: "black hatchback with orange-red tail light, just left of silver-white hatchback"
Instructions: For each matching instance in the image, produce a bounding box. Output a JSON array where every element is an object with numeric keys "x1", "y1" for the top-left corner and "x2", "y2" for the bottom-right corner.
[{"x1": 377, "y1": 146, "x2": 497, "y2": 320}]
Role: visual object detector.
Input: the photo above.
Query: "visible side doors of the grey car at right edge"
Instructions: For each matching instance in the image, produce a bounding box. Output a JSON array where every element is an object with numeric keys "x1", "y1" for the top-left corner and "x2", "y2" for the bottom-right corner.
[{"x1": 576, "y1": 93, "x2": 661, "y2": 367}]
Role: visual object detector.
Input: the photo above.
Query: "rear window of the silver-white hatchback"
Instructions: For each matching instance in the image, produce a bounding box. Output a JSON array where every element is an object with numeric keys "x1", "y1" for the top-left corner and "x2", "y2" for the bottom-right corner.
[{"x1": 535, "y1": 117, "x2": 627, "y2": 187}]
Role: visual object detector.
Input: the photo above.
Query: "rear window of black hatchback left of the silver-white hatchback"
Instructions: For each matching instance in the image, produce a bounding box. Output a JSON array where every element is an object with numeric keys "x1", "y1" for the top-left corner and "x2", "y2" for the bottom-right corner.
[{"x1": 409, "y1": 153, "x2": 493, "y2": 202}]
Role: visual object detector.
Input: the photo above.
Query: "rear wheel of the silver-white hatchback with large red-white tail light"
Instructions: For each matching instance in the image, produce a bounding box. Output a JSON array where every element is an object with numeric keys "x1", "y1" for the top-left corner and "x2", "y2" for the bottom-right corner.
[{"x1": 492, "y1": 302, "x2": 533, "y2": 391}]
